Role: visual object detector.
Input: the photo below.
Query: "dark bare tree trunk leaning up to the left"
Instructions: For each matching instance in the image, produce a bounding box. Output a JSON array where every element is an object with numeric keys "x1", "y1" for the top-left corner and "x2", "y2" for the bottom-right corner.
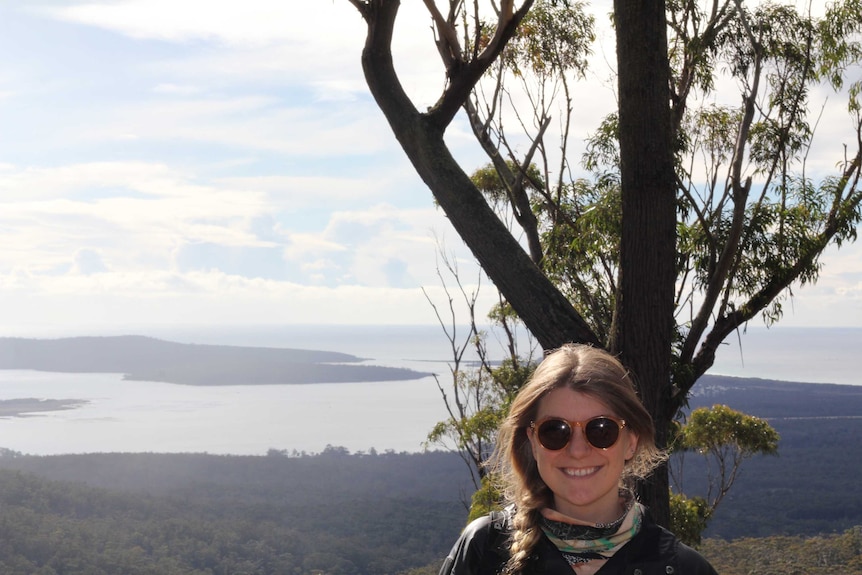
[{"x1": 362, "y1": 0, "x2": 599, "y2": 349}]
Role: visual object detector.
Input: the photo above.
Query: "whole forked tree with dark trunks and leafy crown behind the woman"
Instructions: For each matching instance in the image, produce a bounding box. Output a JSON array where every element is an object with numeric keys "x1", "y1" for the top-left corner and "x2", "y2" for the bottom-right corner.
[{"x1": 351, "y1": 0, "x2": 862, "y2": 523}]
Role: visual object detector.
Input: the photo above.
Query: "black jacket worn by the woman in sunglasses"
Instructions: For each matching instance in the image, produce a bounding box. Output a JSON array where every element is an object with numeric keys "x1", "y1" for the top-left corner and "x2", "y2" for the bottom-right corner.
[{"x1": 439, "y1": 514, "x2": 717, "y2": 575}]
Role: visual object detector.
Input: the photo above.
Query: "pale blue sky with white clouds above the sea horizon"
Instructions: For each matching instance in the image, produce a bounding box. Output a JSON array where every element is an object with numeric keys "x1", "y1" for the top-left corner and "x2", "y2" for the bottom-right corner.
[{"x1": 0, "y1": 0, "x2": 862, "y2": 335}]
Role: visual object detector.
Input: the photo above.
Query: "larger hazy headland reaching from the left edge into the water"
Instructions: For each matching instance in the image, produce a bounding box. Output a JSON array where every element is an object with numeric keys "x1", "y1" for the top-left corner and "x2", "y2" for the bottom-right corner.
[{"x1": 0, "y1": 335, "x2": 430, "y2": 385}]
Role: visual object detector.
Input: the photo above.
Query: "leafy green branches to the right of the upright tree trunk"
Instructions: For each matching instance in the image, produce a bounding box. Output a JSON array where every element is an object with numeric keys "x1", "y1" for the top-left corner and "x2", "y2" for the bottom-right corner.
[{"x1": 672, "y1": 1, "x2": 862, "y2": 337}]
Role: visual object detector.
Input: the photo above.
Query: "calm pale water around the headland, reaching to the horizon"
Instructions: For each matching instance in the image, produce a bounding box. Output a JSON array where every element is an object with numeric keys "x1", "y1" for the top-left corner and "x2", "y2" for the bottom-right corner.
[{"x1": 0, "y1": 326, "x2": 862, "y2": 454}]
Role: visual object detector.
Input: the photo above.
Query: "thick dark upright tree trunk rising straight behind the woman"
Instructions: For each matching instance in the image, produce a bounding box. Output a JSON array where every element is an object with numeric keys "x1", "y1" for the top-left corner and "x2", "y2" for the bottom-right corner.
[{"x1": 611, "y1": 0, "x2": 676, "y2": 526}]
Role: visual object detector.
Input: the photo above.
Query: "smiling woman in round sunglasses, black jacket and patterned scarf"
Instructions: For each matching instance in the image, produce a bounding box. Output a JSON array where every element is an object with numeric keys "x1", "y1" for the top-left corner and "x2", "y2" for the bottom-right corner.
[{"x1": 440, "y1": 345, "x2": 716, "y2": 575}]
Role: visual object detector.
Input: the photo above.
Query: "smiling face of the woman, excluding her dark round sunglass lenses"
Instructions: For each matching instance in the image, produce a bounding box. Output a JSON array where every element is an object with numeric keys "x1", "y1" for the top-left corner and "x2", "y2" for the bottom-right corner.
[{"x1": 528, "y1": 388, "x2": 638, "y2": 523}]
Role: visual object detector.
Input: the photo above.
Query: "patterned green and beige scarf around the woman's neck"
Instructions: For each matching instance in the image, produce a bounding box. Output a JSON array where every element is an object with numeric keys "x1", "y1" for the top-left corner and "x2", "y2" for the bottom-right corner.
[{"x1": 541, "y1": 490, "x2": 644, "y2": 567}]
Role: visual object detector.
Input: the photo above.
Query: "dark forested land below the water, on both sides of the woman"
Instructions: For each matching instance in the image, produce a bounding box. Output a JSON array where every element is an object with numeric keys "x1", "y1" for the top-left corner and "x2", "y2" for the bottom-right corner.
[{"x1": 0, "y1": 377, "x2": 862, "y2": 575}]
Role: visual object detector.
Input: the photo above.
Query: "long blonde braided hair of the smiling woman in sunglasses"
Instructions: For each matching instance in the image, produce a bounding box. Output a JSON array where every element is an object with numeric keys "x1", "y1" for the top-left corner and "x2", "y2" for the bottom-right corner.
[{"x1": 492, "y1": 344, "x2": 666, "y2": 573}]
